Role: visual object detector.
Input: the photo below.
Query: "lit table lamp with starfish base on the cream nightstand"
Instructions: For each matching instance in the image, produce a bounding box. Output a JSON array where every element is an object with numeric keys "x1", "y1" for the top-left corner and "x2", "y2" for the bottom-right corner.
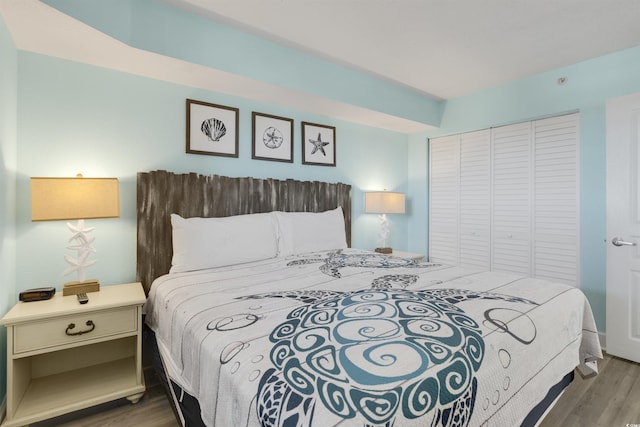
[{"x1": 31, "y1": 174, "x2": 120, "y2": 295}]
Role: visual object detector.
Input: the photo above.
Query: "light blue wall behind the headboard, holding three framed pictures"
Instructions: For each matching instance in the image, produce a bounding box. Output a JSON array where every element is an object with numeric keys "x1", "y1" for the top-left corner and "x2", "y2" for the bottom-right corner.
[{"x1": 17, "y1": 52, "x2": 409, "y2": 289}]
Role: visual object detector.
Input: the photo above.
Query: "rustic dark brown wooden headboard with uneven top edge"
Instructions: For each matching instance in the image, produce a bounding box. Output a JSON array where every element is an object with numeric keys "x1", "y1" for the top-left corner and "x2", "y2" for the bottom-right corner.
[{"x1": 136, "y1": 170, "x2": 351, "y2": 293}]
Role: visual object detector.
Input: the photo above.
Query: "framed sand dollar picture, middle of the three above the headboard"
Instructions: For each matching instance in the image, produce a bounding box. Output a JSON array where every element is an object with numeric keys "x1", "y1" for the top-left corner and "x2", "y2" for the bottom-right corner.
[{"x1": 251, "y1": 111, "x2": 293, "y2": 163}]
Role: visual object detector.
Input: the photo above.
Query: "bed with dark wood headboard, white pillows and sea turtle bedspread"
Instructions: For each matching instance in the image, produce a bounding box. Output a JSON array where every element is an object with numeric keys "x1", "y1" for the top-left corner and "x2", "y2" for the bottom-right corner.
[{"x1": 138, "y1": 171, "x2": 602, "y2": 427}]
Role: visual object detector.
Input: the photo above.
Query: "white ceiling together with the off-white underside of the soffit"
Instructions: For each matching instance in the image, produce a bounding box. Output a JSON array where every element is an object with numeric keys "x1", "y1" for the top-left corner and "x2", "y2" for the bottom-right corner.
[{"x1": 0, "y1": 0, "x2": 640, "y2": 134}]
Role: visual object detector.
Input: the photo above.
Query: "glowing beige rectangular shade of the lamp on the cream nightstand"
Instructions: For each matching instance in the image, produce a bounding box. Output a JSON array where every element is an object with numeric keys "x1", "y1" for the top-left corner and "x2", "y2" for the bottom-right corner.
[{"x1": 31, "y1": 175, "x2": 120, "y2": 221}]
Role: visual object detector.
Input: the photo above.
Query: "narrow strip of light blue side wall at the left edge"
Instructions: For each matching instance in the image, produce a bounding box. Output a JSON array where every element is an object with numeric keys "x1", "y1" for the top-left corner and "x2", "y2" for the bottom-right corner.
[{"x1": 0, "y1": 12, "x2": 18, "y2": 400}]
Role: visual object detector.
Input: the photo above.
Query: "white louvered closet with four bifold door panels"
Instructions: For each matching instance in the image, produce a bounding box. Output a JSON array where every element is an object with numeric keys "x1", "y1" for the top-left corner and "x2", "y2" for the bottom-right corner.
[{"x1": 429, "y1": 113, "x2": 580, "y2": 286}]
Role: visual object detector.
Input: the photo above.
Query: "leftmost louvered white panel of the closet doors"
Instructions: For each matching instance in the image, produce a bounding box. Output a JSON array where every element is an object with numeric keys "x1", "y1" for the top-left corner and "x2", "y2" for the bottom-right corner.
[{"x1": 429, "y1": 135, "x2": 460, "y2": 265}]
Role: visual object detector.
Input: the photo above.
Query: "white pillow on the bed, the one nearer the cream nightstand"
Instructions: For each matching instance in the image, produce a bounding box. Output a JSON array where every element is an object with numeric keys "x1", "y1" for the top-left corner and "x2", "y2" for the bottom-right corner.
[{"x1": 169, "y1": 213, "x2": 278, "y2": 273}]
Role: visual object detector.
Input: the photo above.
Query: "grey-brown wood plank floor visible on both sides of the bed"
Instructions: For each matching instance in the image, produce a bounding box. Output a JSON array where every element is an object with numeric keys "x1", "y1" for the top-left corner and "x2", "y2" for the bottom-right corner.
[{"x1": 31, "y1": 355, "x2": 640, "y2": 427}]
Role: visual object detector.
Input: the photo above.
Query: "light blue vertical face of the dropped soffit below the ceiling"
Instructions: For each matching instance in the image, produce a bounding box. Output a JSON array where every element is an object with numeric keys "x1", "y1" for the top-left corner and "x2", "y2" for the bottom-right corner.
[{"x1": 45, "y1": 0, "x2": 442, "y2": 129}]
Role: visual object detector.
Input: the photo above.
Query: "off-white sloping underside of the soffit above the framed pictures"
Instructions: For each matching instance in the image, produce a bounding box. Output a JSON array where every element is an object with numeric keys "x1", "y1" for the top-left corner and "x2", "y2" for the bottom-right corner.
[{"x1": 0, "y1": 0, "x2": 440, "y2": 134}]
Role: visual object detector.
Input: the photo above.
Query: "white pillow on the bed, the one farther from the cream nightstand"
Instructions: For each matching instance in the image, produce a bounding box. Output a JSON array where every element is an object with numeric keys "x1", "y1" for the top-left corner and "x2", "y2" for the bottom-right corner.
[{"x1": 274, "y1": 206, "x2": 347, "y2": 256}]
